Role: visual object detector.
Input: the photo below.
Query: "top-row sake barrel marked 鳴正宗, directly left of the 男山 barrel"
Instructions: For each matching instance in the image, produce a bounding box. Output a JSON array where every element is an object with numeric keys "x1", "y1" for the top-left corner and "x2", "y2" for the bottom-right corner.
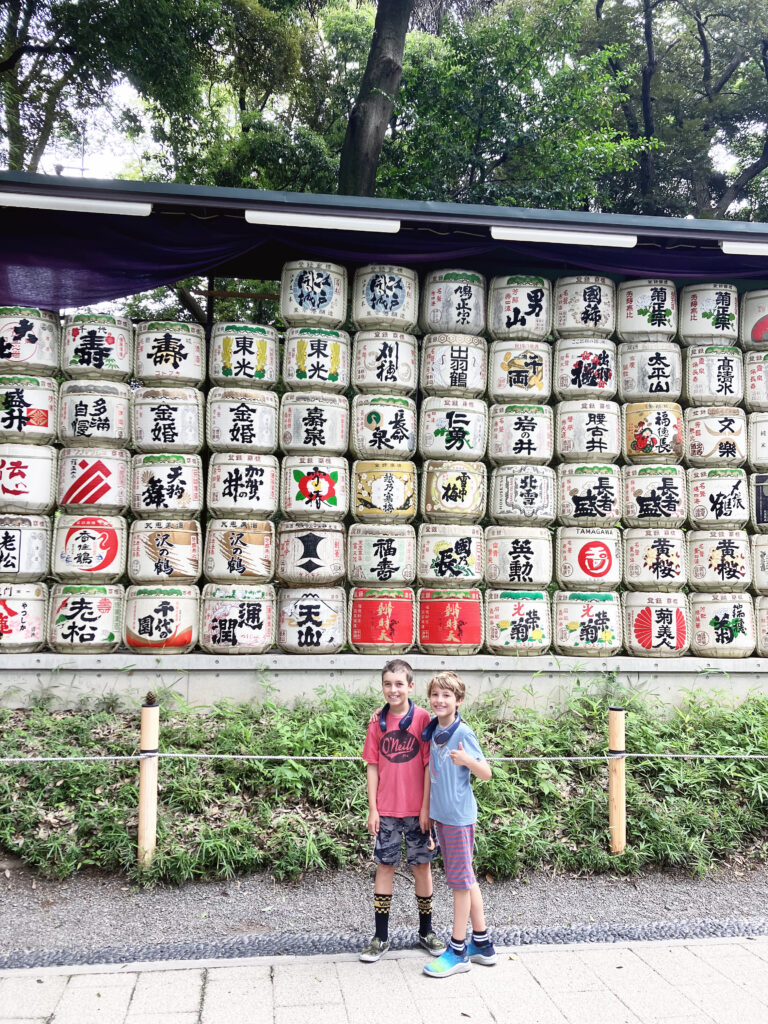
[{"x1": 420, "y1": 270, "x2": 485, "y2": 335}]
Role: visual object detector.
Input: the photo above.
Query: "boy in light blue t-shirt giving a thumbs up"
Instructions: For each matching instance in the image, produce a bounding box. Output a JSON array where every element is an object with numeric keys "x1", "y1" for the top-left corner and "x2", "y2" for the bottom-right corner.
[{"x1": 422, "y1": 672, "x2": 497, "y2": 978}]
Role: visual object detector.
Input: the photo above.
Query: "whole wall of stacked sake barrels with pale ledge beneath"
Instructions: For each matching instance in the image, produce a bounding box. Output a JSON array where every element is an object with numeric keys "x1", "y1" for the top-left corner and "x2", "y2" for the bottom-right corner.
[{"x1": 0, "y1": 272, "x2": 768, "y2": 704}]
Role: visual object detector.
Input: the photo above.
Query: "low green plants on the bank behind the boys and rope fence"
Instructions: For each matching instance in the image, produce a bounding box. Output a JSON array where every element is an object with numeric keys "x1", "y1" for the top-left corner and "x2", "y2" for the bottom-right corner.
[{"x1": 0, "y1": 686, "x2": 768, "y2": 883}]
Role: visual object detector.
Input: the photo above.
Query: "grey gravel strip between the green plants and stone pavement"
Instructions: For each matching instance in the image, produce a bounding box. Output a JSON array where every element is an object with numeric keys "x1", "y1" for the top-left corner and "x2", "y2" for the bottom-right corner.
[{"x1": 0, "y1": 859, "x2": 768, "y2": 968}]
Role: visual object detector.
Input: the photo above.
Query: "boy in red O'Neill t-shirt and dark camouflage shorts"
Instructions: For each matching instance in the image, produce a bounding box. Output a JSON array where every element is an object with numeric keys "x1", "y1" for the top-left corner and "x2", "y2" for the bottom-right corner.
[{"x1": 360, "y1": 658, "x2": 445, "y2": 964}]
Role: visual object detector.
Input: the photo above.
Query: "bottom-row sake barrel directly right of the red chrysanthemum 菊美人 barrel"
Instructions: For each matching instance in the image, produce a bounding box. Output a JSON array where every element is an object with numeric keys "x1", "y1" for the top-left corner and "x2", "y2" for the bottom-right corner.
[{"x1": 690, "y1": 593, "x2": 757, "y2": 657}]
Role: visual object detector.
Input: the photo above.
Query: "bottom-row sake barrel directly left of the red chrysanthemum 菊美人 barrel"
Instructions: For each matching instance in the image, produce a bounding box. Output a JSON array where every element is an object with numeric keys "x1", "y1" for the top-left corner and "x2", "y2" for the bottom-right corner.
[{"x1": 552, "y1": 590, "x2": 624, "y2": 657}]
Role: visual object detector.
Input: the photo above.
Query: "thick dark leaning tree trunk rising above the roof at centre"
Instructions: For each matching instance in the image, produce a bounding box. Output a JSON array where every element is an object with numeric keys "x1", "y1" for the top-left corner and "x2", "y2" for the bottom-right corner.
[{"x1": 339, "y1": 0, "x2": 414, "y2": 196}]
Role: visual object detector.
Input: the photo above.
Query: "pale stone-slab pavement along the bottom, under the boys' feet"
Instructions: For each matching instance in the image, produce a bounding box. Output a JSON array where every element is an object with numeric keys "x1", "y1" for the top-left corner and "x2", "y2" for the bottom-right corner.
[{"x1": 0, "y1": 938, "x2": 768, "y2": 1024}]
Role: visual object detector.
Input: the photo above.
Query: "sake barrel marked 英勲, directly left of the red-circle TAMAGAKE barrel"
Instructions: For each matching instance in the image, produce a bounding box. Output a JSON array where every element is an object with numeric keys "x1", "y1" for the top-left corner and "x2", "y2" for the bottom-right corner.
[{"x1": 485, "y1": 526, "x2": 552, "y2": 590}]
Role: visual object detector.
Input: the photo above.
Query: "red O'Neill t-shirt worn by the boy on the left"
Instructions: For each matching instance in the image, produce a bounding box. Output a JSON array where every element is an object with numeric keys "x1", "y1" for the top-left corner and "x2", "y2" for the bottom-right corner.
[{"x1": 362, "y1": 707, "x2": 429, "y2": 818}]
